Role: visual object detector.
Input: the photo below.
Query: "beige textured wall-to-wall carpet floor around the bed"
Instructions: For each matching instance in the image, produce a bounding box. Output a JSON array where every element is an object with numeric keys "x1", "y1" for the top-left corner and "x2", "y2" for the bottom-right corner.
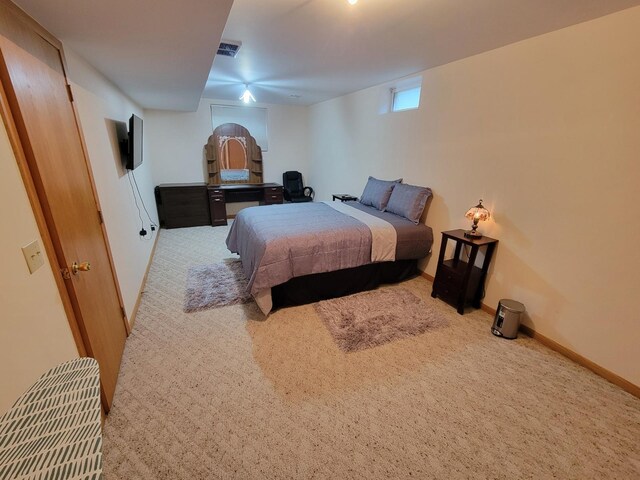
[{"x1": 103, "y1": 227, "x2": 640, "y2": 480}]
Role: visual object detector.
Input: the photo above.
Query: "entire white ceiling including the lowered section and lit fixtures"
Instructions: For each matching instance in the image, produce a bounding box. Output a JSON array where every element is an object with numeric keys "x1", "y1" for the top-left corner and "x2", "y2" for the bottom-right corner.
[{"x1": 14, "y1": 0, "x2": 640, "y2": 110}]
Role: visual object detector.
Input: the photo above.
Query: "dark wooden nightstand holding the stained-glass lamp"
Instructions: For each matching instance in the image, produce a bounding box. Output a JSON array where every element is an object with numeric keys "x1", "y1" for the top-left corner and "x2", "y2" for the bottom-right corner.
[{"x1": 431, "y1": 230, "x2": 498, "y2": 315}]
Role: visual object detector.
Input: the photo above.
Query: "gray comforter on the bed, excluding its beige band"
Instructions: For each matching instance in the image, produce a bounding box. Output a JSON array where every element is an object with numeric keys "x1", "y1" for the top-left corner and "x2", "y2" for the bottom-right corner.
[{"x1": 227, "y1": 202, "x2": 433, "y2": 295}]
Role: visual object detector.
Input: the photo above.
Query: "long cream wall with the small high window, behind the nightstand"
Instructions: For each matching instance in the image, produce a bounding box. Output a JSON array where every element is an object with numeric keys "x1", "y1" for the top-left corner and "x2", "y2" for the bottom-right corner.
[{"x1": 310, "y1": 7, "x2": 640, "y2": 385}]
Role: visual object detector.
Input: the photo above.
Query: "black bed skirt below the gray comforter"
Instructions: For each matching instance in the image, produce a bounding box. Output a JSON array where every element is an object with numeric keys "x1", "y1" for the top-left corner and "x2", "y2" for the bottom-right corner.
[{"x1": 271, "y1": 260, "x2": 418, "y2": 310}]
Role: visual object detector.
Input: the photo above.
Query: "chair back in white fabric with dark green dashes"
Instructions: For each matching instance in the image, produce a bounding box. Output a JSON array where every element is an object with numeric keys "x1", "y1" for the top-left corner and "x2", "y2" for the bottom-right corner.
[{"x1": 0, "y1": 358, "x2": 102, "y2": 480}]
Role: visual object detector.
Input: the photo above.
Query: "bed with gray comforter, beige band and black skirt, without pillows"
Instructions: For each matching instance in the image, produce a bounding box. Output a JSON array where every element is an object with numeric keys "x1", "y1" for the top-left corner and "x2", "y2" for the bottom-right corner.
[{"x1": 227, "y1": 179, "x2": 433, "y2": 315}]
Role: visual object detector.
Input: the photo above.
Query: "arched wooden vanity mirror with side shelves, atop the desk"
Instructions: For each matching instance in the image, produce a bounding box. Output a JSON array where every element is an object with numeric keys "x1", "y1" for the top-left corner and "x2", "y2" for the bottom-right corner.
[{"x1": 204, "y1": 123, "x2": 262, "y2": 185}]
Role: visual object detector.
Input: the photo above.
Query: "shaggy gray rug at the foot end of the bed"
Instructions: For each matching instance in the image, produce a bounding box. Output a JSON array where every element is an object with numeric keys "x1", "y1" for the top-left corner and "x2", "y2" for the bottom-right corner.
[{"x1": 184, "y1": 260, "x2": 251, "y2": 312}]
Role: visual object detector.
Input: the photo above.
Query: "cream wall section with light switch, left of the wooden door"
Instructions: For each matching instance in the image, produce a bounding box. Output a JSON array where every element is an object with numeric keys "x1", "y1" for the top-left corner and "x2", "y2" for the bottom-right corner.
[{"x1": 0, "y1": 119, "x2": 78, "y2": 414}]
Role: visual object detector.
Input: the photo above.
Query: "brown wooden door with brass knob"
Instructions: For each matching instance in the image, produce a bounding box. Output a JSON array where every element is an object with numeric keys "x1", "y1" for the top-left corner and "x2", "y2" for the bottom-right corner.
[{"x1": 0, "y1": 19, "x2": 127, "y2": 411}]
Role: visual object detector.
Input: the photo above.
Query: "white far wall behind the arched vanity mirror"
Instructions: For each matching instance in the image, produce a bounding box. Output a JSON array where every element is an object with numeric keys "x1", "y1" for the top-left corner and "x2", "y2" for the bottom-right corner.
[{"x1": 145, "y1": 98, "x2": 312, "y2": 185}]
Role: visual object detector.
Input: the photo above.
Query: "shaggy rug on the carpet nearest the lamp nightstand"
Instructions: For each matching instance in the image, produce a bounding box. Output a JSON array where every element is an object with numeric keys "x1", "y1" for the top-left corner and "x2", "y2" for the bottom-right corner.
[{"x1": 315, "y1": 288, "x2": 447, "y2": 352}]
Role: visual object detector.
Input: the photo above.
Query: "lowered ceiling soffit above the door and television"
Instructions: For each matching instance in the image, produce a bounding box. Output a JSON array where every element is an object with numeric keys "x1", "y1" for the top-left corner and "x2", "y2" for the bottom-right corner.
[{"x1": 13, "y1": 0, "x2": 233, "y2": 110}]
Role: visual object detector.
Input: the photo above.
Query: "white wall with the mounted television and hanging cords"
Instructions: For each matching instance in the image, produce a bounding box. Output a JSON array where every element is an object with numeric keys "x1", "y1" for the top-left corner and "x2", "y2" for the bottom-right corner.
[{"x1": 65, "y1": 50, "x2": 158, "y2": 318}]
